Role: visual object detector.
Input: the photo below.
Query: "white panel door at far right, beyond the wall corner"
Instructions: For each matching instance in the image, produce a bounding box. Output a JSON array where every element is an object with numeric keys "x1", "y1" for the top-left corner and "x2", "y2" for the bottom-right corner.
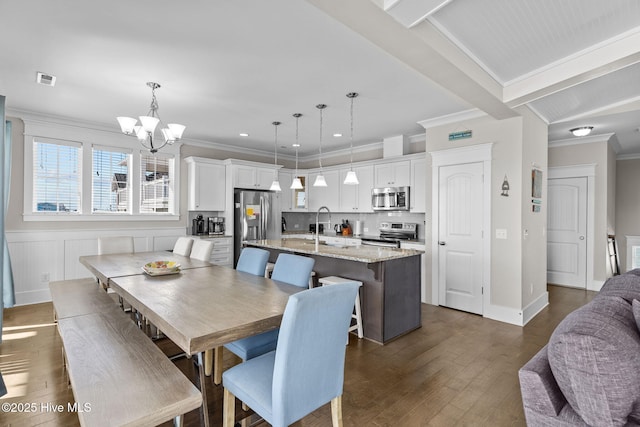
[{"x1": 547, "y1": 177, "x2": 587, "y2": 289}]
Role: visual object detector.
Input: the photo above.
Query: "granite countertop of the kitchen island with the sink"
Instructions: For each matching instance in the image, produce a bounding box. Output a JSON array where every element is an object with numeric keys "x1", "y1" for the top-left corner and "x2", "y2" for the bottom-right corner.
[{"x1": 245, "y1": 238, "x2": 424, "y2": 263}]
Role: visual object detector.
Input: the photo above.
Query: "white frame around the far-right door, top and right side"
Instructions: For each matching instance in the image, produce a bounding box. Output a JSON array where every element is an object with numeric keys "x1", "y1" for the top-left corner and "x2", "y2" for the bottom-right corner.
[{"x1": 545, "y1": 163, "x2": 601, "y2": 291}]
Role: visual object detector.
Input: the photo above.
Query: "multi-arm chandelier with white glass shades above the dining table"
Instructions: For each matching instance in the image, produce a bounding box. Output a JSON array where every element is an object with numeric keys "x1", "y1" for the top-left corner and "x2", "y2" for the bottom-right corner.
[{"x1": 117, "y1": 82, "x2": 186, "y2": 153}]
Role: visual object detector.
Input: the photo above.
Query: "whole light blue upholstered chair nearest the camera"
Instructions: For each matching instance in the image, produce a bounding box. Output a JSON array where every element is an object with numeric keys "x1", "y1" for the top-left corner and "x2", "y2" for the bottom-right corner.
[{"x1": 222, "y1": 283, "x2": 358, "y2": 427}]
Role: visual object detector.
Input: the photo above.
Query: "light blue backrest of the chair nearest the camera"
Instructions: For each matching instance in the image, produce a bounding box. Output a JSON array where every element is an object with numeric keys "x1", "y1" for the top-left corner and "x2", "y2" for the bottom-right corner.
[{"x1": 272, "y1": 283, "x2": 358, "y2": 425}]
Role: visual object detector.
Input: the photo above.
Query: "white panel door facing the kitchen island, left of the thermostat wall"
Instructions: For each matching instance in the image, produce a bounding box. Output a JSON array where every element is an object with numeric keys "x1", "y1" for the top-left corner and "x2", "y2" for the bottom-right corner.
[{"x1": 438, "y1": 163, "x2": 484, "y2": 314}]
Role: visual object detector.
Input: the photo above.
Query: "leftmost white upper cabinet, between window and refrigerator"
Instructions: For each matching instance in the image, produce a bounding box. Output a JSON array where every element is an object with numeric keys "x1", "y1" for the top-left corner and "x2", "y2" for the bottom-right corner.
[{"x1": 185, "y1": 157, "x2": 225, "y2": 211}]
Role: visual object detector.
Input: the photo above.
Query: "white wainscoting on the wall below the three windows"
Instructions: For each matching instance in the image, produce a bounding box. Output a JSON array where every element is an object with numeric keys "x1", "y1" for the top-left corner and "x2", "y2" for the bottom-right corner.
[{"x1": 6, "y1": 227, "x2": 185, "y2": 305}]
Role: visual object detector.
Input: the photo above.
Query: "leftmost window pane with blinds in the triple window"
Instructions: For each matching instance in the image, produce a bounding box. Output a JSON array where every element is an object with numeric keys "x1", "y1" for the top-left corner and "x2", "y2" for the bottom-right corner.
[{"x1": 32, "y1": 140, "x2": 82, "y2": 213}]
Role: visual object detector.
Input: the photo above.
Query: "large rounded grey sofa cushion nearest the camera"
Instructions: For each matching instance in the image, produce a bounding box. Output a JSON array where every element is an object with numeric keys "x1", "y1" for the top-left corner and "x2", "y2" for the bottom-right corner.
[{"x1": 547, "y1": 296, "x2": 640, "y2": 426}]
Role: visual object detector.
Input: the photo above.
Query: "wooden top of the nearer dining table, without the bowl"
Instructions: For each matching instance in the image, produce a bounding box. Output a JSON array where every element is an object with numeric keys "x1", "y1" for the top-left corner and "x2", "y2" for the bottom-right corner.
[{"x1": 109, "y1": 265, "x2": 304, "y2": 354}]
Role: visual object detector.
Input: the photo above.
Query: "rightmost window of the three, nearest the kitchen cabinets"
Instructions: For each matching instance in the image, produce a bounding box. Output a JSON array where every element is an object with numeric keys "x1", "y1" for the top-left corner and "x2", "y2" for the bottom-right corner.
[{"x1": 140, "y1": 153, "x2": 174, "y2": 214}]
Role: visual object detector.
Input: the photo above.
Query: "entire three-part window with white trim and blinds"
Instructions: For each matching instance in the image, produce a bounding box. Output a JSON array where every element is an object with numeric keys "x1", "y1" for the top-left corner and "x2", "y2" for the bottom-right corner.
[{"x1": 23, "y1": 117, "x2": 182, "y2": 221}]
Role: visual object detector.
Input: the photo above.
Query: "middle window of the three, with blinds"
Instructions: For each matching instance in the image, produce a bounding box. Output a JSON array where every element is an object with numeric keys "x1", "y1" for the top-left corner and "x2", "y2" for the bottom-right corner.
[{"x1": 91, "y1": 147, "x2": 131, "y2": 213}]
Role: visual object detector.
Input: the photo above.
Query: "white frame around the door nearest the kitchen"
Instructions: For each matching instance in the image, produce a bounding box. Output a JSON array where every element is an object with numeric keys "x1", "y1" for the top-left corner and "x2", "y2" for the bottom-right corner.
[{"x1": 429, "y1": 142, "x2": 493, "y2": 313}]
